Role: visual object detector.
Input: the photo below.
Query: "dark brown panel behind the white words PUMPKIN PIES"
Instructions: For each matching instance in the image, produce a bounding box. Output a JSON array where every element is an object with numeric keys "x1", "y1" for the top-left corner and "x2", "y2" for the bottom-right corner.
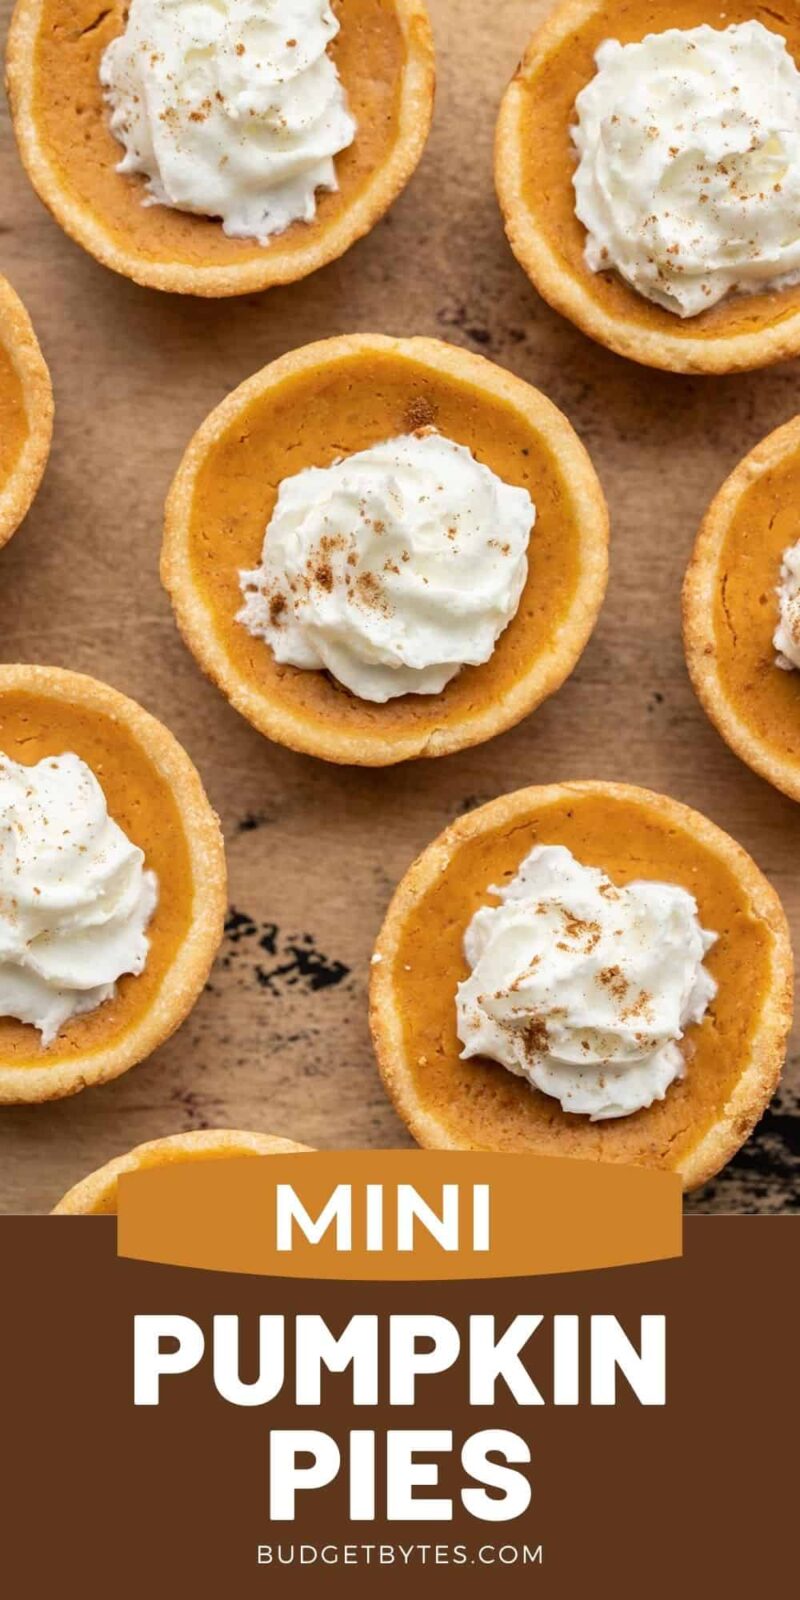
[{"x1": 0, "y1": 1216, "x2": 800, "y2": 1600}]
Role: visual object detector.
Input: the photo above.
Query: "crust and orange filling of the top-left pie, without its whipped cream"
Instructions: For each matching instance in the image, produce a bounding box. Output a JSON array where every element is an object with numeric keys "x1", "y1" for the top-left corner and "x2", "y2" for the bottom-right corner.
[{"x1": 6, "y1": 0, "x2": 435, "y2": 296}]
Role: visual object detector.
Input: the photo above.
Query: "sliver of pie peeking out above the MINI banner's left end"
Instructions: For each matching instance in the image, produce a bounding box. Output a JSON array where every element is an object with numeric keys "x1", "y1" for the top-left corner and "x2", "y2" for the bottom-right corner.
[{"x1": 51, "y1": 1128, "x2": 310, "y2": 1216}]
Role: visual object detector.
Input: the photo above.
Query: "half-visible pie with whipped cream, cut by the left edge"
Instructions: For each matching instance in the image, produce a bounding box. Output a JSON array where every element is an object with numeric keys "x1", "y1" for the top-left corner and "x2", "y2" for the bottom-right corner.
[{"x1": 0, "y1": 666, "x2": 226, "y2": 1102}]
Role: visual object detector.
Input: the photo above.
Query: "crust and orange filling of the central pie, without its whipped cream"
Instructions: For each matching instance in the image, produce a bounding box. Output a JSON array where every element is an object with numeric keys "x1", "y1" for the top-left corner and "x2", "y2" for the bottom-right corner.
[{"x1": 162, "y1": 334, "x2": 608, "y2": 766}]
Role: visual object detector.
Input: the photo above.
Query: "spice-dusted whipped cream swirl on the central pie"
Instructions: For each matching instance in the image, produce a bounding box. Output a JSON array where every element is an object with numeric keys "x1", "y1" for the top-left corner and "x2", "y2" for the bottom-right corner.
[{"x1": 238, "y1": 429, "x2": 536, "y2": 702}]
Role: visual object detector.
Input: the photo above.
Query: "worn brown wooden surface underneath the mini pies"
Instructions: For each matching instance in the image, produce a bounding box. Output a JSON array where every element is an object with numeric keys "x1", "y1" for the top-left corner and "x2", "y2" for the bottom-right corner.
[{"x1": 0, "y1": 0, "x2": 800, "y2": 1211}]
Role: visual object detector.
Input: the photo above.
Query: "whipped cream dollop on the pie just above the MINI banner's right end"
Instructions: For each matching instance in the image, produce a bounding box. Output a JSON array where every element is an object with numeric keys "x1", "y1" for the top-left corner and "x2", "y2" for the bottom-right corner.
[{"x1": 456, "y1": 845, "x2": 717, "y2": 1122}]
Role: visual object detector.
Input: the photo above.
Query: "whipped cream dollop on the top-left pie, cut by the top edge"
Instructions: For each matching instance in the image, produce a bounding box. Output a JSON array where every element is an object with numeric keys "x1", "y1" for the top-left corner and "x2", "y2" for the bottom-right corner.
[{"x1": 99, "y1": 0, "x2": 355, "y2": 245}]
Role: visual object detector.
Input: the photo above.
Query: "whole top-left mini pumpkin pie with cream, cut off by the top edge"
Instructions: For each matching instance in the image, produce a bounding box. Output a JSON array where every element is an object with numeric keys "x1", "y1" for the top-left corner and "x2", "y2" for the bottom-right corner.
[{"x1": 6, "y1": 0, "x2": 434, "y2": 296}]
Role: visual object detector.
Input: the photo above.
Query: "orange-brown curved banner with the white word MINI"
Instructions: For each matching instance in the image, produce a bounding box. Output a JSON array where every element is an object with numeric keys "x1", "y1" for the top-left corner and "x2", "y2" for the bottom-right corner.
[{"x1": 117, "y1": 1150, "x2": 682, "y2": 1282}]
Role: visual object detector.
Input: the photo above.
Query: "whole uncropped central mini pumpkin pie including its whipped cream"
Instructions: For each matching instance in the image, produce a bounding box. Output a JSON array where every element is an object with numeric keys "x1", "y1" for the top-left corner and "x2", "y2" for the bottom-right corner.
[{"x1": 162, "y1": 334, "x2": 608, "y2": 766}]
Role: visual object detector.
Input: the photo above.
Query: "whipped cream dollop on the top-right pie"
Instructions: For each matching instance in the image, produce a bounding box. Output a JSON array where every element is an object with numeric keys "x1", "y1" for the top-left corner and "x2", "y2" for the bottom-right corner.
[{"x1": 573, "y1": 22, "x2": 800, "y2": 317}]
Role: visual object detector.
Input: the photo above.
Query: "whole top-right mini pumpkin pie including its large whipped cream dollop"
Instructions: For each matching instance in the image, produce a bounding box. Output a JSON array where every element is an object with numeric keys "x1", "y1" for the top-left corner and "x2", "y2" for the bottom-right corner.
[{"x1": 496, "y1": 0, "x2": 800, "y2": 373}]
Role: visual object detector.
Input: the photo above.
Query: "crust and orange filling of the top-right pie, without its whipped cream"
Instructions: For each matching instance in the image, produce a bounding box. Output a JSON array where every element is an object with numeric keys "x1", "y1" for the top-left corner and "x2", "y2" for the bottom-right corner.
[{"x1": 494, "y1": 0, "x2": 800, "y2": 373}]
